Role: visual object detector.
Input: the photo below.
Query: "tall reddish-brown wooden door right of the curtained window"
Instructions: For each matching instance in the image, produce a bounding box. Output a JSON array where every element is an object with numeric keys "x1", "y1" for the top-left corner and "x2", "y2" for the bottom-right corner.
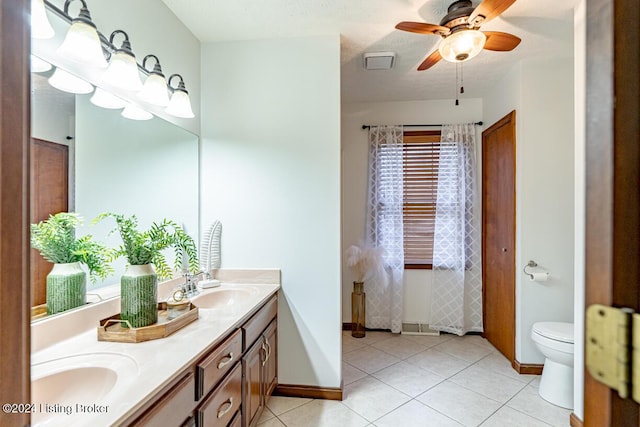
[{"x1": 482, "y1": 111, "x2": 516, "y2": 363}]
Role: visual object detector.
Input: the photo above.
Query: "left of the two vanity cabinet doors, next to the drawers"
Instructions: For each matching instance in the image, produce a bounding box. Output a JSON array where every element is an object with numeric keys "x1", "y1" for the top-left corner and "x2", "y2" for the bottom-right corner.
[{"x1": 242, "y1": 338, "x2": 266, "y2": 427}]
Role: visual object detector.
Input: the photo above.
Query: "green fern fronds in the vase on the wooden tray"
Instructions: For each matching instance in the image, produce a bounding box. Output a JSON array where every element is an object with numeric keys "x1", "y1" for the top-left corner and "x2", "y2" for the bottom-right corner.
[{"x1": 94, "y1": 212, "x2": 200, "y2": 278}]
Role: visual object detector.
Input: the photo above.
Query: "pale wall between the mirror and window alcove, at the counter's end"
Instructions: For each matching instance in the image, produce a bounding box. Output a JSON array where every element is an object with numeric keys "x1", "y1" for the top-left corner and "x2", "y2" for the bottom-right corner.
[{"x1": 201, "y1": 35, "x2": 341, "y2": 387}]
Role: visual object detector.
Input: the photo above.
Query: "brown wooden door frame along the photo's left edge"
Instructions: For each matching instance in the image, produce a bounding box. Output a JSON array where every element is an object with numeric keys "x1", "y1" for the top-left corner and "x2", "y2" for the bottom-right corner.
[{"x1": 0, "y1": 0, "x2": 31, "y2": 427}]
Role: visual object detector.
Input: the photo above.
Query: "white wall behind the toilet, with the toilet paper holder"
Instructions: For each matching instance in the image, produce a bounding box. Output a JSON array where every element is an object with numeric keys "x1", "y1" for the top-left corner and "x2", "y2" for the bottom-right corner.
[{"x1": 484, "y1": 56, "x2": 574, "y2": 363}]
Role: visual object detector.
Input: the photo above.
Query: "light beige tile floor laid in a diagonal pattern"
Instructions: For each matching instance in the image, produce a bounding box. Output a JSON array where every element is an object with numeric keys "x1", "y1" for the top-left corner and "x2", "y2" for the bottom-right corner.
[{"x1": 258, "y1": 331, "x2": 571, "y2": 427}]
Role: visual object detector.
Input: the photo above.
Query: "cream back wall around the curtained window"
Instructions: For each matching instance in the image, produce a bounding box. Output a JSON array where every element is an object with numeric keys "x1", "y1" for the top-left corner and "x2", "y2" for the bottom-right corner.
[{"x1": 342, "y1": 99, "x2": 483, "y2": 323}]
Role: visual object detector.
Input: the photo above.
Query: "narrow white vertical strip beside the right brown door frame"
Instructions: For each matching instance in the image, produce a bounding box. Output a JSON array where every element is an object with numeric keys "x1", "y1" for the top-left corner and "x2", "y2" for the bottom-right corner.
[{"x1": 573, "y1": 0, "x2": 587, "y2": 420}]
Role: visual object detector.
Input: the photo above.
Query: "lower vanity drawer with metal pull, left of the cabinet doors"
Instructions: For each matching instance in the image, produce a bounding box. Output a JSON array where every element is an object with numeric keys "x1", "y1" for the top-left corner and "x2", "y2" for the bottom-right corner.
[{"x1": 197, "y1": 363, "x2": 242, "y2": 427}]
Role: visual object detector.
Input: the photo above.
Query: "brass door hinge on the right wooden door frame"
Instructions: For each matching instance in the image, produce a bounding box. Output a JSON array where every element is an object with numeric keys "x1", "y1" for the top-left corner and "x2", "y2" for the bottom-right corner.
[{"x1": 585, "y1": 304, "x2": 640, "y2": 403}]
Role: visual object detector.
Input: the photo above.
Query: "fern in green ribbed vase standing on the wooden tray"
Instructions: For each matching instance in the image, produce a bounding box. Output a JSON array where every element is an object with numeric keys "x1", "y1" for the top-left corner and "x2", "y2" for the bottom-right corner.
[{"x1": 94, "y1": 212, "x2": 199, "y2": 328}]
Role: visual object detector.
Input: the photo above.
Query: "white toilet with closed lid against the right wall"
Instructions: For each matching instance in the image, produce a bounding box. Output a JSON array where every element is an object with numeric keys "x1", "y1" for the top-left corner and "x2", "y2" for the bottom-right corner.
[{"x1": 531, "y1": 322, "x2": 573, "y2": 409}]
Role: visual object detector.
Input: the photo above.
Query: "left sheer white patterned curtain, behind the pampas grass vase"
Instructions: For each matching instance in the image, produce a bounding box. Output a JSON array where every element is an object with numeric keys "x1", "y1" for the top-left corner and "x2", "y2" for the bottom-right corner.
[{"x1": 365, "y1": 126, "x2": 404, "y2": 333}]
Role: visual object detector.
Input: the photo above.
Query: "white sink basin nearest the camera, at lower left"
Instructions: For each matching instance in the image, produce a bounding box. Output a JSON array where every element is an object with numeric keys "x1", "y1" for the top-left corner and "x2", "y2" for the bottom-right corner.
[{"x1": 31, "y1": 353, "x2": 138, "y2": 426}]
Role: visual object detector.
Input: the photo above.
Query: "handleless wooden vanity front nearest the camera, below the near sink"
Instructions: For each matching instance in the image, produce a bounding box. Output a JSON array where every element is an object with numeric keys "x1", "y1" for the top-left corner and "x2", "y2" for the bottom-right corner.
[{"x1": 132, "y1": 372, "x2": 195, "y2": 427}]
